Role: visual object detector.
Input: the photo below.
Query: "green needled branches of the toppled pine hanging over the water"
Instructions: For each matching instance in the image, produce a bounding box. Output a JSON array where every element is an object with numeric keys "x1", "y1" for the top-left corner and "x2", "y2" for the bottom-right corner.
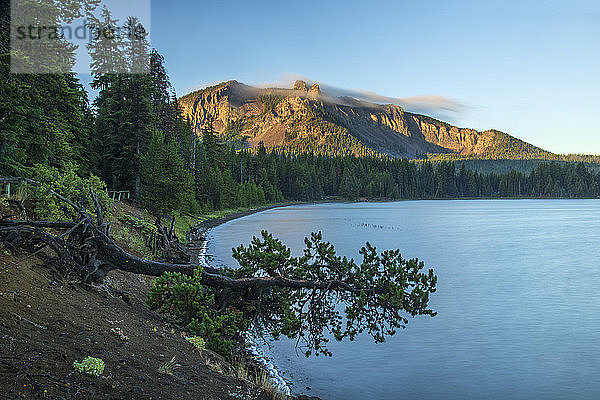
[{"x1": 148, "y1": 231, "x2": 437, "y2": 356}]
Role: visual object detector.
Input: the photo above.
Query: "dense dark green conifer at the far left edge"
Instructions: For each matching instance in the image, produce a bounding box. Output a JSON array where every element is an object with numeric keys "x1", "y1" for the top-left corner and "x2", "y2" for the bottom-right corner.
[{"x1": 0, "y1": 1, "x2": 92, "y2": 176}]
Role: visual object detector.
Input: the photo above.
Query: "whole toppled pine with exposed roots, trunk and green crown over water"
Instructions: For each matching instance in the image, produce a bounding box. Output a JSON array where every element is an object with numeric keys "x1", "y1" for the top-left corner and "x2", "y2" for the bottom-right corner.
[{"x1": 0, "y1": 179, "x2": 437, "y2": 355}]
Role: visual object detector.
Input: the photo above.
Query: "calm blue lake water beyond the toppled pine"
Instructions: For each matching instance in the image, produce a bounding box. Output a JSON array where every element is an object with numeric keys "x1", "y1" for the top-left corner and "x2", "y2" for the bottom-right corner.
[{"x1": 208, "y1": 200, "x2": 600, "y2": 400}]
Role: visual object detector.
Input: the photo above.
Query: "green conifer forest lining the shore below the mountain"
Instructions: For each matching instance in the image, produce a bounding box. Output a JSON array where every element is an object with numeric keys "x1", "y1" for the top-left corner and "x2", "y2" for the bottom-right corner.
[{"x1": 0, "y1": 51, "x2": 600, "y2": 219}]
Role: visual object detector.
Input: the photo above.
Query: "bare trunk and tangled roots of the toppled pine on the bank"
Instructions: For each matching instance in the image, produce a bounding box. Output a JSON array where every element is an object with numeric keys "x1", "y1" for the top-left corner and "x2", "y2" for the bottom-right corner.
[{"x1": 0, "y1": 219, "x2": 379, "y2": 293}]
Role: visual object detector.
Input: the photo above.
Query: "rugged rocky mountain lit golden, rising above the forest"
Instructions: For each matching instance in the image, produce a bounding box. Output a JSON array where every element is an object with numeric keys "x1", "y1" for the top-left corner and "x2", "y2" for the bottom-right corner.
[{"x1": 180, "y1": 81, "x2": 554, "y2": 159}]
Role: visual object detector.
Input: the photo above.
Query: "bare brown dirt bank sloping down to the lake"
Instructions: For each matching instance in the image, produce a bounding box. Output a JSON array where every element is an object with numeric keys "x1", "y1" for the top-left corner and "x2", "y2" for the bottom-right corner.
[{"x1": 0, "y1": 250, "x2": 278, "y2": 400}]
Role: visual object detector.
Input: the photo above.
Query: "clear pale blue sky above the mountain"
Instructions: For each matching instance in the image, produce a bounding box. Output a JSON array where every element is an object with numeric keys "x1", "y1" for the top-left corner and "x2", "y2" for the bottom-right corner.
[{"x1": 146, "y1": 0, "x2": 600, "y2": 154}]
